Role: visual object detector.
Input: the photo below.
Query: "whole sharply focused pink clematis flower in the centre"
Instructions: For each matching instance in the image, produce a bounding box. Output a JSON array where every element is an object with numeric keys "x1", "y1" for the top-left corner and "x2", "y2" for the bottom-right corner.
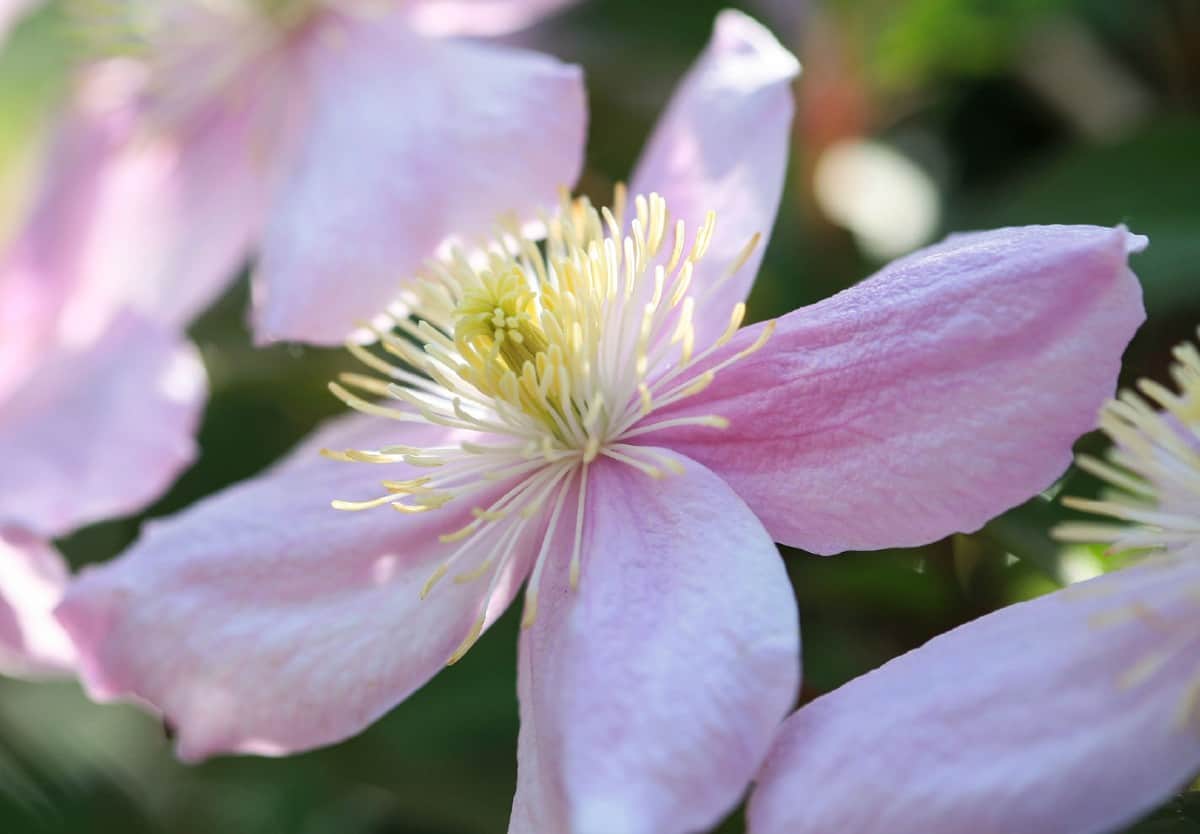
[{"x1": 58, "y1": 12, "x2": 1142, "y2": 834}]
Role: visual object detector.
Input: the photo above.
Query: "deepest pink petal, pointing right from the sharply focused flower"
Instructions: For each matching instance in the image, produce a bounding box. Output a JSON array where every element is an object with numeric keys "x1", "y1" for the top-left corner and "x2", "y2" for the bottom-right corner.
[{"x1": 647, "y1": 226, "x2": 1145, "y2": 553}]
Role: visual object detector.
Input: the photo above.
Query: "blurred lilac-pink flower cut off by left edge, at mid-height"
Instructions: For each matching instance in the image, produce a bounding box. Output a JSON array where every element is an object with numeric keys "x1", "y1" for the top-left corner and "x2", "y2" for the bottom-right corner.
[{"x1": 0, "y1": 303, "x2": 205, "y2": 673}]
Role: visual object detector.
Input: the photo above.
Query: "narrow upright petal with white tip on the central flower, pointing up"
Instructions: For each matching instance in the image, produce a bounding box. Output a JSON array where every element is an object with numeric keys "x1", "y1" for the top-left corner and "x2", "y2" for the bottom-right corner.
[{"x1": 631, "y1": 11, "x2": 800, "y2": 343}]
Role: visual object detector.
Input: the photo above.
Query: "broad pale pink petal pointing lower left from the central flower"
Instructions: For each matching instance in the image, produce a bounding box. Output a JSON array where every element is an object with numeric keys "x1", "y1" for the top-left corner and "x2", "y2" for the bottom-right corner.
[{"x1": 58, "y1": 416, "x2": 532, "y2": 760}]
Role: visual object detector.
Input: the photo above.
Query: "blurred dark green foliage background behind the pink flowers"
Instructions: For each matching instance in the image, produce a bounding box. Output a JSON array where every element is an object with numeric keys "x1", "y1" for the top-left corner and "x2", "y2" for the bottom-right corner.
[{"x1": 0, "y1": 0, "x2": 1200, "y2": 834}]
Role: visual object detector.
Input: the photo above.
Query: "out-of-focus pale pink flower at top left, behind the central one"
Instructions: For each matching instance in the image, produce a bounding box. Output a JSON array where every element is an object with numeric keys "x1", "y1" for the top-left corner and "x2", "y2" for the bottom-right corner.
[{"x1": 10, "y1": 0, "x2": 586, "y2": 342}]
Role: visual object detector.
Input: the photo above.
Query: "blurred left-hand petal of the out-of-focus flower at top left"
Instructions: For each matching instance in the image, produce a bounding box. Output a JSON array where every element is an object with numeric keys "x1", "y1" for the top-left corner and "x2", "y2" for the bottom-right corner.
[{"x1": 0, "y1": 62, "x2": 266, "y2": 352}]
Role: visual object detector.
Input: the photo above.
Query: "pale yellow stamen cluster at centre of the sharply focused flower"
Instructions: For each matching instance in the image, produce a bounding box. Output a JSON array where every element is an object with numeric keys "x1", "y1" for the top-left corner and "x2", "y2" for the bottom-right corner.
[{"x1": 326, "y1": 188, "x2": 770, "y2": 661}]
